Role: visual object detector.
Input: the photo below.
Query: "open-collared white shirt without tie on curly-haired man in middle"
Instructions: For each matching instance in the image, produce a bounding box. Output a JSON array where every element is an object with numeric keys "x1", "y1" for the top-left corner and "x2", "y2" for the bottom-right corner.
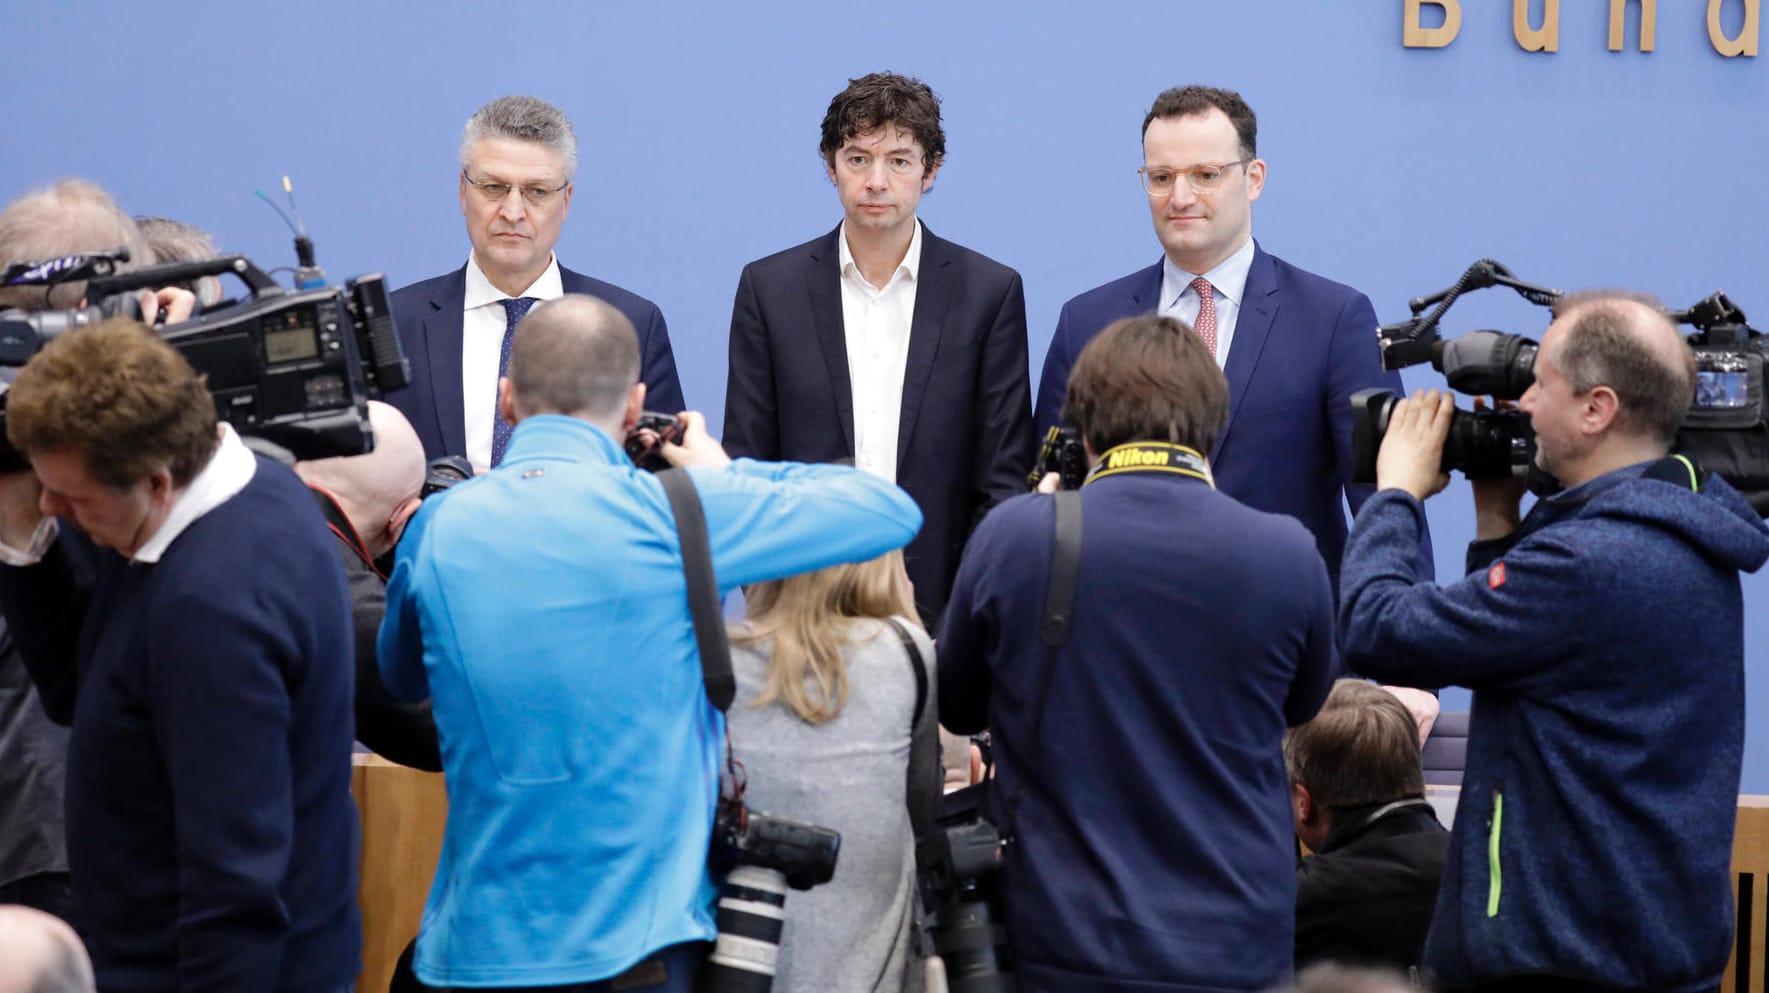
[{"x1": 835, "y1": 219, "x2": 922, "y2": 483}]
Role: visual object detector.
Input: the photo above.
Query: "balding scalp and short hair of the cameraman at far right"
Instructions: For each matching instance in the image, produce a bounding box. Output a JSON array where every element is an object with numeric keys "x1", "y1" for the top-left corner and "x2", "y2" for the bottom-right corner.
[{"x1": 1543, "y1": 290, "x2": 1695, "y2": 446}]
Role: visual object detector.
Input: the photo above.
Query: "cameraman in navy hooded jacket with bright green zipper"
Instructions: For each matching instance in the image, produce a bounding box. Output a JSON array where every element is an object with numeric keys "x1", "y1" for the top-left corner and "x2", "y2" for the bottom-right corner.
[{"x1": 1341, "y1": 292, "x2": 1769, "y2": 993}]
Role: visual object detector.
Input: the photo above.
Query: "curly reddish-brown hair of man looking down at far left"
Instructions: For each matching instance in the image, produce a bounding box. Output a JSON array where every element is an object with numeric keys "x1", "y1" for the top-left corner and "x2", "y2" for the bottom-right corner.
[{"x1": 5, "y1": 317, "x2": 218, "y2": 489}]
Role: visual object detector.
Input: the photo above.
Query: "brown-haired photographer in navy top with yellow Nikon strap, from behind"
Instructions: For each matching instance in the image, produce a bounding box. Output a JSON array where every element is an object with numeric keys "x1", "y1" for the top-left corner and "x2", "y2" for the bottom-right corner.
[{"x1": 939, "y1": 315, "x2": 1336, "y2": 993}]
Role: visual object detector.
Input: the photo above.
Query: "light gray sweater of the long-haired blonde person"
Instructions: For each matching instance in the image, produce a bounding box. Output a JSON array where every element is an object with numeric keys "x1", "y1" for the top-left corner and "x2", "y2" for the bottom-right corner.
[{"x1": 729, "y1": 621, "x2": 941, "y2": 993}]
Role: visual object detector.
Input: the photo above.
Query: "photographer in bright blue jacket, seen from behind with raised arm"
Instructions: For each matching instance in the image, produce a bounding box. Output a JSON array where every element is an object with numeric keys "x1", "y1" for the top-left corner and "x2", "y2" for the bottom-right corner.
[{"x1": 379, "y1": 294, "x2": 922, "y2": 993}]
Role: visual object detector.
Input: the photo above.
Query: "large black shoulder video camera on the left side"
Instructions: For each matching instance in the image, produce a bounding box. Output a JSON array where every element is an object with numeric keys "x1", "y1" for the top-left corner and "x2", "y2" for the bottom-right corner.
[{"x1": 0, "y1": 255, "x2": 410, "y2": 464}]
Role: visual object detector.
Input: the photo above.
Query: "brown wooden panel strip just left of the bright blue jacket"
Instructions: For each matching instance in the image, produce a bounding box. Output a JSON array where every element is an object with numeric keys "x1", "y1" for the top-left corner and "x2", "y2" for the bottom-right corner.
[{"x1": 350, "y1": 754, "x2": 448, "y2": 993}]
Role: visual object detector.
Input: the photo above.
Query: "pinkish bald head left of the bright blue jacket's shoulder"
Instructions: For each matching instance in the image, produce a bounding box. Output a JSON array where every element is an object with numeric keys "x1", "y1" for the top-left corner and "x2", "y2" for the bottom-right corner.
[{"x1": 295, "y1": 400, "x2": 426, "y2": 556}]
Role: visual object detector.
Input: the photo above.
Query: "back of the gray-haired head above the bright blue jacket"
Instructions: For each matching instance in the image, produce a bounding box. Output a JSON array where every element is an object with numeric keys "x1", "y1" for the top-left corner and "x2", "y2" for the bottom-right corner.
[{"x1": 509, "y1": 294, "x2": 639, "y2": 430}]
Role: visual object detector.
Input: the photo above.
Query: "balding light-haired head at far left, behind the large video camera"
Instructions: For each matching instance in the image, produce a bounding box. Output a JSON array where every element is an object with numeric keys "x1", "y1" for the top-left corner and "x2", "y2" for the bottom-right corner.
[{"x1": 0, "y1": 179, "x2": 154, "y2": 310}]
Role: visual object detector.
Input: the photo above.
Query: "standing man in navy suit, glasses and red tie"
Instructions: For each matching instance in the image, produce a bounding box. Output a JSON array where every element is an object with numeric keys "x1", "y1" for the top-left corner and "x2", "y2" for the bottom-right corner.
[{"x1": 1035, "y1": 87, "x2": 1431, "y2": 586}]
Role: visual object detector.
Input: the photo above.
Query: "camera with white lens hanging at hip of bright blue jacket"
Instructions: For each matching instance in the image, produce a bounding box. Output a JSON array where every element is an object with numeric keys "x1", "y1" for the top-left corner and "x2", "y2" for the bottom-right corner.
[{"x1": 701, "y1": 797, "x2": 842, "y2": 993}]
